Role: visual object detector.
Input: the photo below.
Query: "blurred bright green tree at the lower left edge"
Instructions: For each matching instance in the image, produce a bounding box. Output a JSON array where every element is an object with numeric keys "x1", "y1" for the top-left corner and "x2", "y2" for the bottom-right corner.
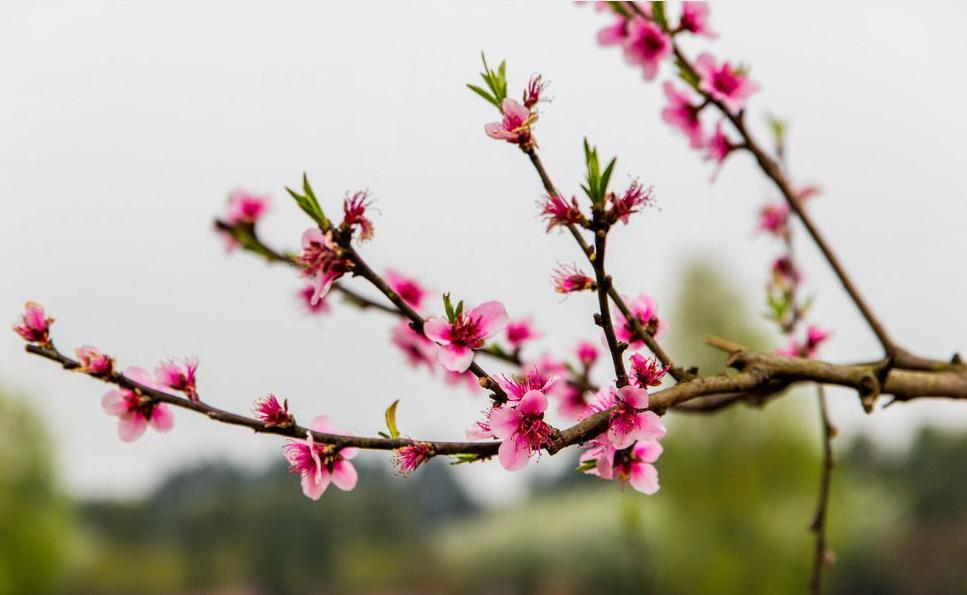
[{"x1": 0, "y1": 394, "x2": 73, "y2": 595}]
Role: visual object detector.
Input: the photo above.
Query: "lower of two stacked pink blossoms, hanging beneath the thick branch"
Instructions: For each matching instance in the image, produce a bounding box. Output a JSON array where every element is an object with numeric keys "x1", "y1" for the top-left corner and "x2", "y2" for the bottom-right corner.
[{"x1": 581, "y1": 438, "x2": 662, "y2": 495}]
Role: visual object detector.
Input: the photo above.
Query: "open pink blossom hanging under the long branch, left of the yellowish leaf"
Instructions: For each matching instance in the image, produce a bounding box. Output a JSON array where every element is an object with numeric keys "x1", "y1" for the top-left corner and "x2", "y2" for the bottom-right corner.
[{"x1": 282, "y1": 416, "x2": 359, "y2": 500}]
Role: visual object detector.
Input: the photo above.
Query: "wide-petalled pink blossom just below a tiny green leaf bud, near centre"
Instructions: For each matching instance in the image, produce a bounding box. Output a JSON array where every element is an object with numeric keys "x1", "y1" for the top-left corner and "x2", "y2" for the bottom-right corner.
[{"x1": 423, "y1": 301, "x2": 508, "y2": 372}]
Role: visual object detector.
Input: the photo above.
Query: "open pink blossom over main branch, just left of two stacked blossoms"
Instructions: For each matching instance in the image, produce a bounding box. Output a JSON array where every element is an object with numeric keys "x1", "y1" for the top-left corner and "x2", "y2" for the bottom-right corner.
[{"x1": 490, "y1": 390, "x2": 554, "y2": 471}]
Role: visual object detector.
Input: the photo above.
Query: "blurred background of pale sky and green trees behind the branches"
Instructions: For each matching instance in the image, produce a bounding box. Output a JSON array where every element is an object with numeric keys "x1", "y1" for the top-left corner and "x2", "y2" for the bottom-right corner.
[{"x1": 0, "y1": 2, "x2": 967, "y2": 593}]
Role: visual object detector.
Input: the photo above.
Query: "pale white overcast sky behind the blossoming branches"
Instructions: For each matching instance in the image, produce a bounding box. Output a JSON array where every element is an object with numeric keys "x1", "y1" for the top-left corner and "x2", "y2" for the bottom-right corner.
[{"x1": 0, "y1": 2, "x2": 967, "y2": 498}]
